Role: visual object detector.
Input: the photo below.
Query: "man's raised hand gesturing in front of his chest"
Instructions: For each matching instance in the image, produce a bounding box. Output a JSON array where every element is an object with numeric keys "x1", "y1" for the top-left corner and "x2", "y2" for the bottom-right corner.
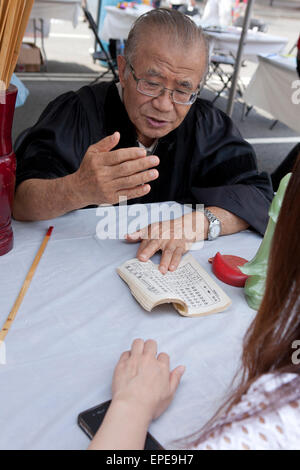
[{"x1": 74, "y1": 132, "x2": 159, "y2": 205}]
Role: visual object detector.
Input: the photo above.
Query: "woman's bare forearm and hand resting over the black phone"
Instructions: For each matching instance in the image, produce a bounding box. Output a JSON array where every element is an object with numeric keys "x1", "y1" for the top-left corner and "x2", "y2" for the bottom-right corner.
[{"x1": 89, "y1": 339, "x2": 184, "y2": 450}]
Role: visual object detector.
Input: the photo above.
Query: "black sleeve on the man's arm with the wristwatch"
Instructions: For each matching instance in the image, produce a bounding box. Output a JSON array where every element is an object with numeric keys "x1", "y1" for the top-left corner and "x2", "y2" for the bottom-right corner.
[{"x1": 192, "y1": 106, "x2": 273, "y2": 234}]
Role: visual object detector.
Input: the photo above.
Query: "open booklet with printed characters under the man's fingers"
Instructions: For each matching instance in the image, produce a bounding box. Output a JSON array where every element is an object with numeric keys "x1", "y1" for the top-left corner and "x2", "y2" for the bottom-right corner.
[{"x1": 117, "y1": 255, "x2": 231, "y2": 317}]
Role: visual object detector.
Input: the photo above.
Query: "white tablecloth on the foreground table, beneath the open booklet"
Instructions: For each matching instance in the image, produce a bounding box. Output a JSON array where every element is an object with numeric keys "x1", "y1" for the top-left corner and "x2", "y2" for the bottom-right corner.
[{"x1": 0, "y1": 204, "x2": 261, "y2": 449}]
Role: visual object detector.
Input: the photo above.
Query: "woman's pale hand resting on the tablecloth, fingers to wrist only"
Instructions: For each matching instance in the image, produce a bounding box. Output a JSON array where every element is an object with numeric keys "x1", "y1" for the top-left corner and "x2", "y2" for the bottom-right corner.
[{"x1": 112, "y1": 339, "x2": 185, "y2": 423}]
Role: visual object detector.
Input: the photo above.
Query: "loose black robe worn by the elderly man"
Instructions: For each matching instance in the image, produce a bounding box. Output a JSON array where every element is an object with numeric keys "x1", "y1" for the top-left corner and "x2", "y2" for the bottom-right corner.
[{"x1": 16, "y1": 82, "x2": 273, "y2": 234}]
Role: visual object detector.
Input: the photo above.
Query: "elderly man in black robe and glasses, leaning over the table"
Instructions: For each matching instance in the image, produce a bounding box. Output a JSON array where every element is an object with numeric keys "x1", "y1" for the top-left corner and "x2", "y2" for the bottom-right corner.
[{"x1": 14, "y1": 9, "x2": 272, "y2": 273}]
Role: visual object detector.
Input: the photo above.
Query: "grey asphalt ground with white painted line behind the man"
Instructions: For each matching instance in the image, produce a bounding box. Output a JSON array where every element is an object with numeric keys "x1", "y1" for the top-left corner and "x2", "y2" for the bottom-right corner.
[{"x1": 13, "y1": 0, "x2": 300, "y2": 176}]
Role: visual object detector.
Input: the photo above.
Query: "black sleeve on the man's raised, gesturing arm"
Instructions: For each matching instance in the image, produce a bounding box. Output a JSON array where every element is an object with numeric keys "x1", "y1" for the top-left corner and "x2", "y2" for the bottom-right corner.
[{"x1": 16, "y1": 92, "x2": 91, "y2": 187}]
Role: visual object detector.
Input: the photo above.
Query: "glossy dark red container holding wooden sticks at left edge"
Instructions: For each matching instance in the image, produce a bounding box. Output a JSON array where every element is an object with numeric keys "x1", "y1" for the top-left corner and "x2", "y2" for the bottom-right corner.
[{"x1": 0, "y1": 85, "x2": 18, "y2": 256}]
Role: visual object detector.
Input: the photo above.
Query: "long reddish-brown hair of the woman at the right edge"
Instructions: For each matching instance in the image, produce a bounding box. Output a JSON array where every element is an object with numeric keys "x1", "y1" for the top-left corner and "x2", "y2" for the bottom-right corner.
[{"x1": 181, "y1": 155, "x2": 300, "y2": 447}]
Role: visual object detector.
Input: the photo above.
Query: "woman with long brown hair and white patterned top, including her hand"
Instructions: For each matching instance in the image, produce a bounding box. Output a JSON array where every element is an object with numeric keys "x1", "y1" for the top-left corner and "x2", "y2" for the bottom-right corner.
[{"x1": 89, "y1": 154, "x2": 300, "y2": 450}]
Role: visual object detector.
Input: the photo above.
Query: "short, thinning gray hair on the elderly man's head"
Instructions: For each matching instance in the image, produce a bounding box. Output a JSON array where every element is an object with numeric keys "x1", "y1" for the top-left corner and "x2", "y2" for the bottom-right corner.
[{"x1": 124, "y1": 8, "x2": 208, "y2": 87}]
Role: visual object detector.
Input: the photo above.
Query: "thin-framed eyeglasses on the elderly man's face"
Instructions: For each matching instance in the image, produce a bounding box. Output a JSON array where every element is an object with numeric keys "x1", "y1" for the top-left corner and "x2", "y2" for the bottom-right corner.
[{"x1": 129, "y1": 64, "x2": 199, "y2": 105}]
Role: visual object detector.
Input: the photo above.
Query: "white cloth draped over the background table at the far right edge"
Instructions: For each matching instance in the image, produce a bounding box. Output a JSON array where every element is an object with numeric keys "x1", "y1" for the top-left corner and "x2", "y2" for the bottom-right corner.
[{"x1": 243, "y1": 56, "x2": 300, "y2": 133}]
